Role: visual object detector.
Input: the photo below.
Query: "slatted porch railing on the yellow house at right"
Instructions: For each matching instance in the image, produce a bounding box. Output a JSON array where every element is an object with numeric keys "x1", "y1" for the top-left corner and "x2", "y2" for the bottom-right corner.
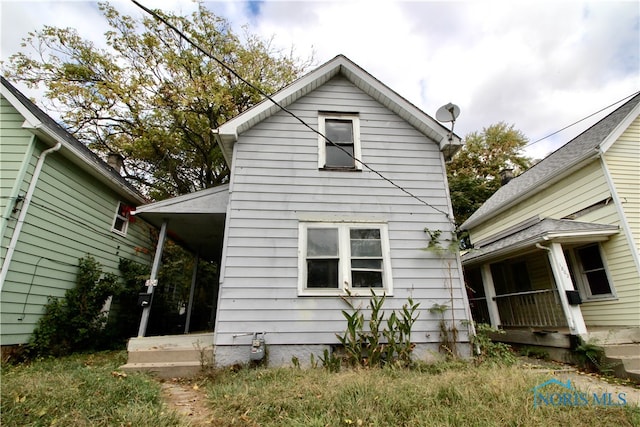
[{"x1": 495, "y1": 289, "x2": 567, "y2": 327}]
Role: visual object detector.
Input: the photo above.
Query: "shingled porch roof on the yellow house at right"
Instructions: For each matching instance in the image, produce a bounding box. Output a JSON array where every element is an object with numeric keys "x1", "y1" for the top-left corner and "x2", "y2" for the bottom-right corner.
[{"x1": 462, "y1": 218, "x2": 619, "y2": 265}]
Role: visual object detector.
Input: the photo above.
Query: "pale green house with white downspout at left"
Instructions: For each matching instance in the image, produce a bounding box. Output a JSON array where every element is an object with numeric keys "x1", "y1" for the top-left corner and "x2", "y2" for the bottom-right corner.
[{"x1": 0, "y1": 78, "x2": 151, "y2": 346}]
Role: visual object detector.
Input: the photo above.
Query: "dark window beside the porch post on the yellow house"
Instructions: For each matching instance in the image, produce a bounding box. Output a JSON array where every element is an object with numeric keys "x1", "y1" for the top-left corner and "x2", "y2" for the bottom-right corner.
[{"x1": 565, "y1": 243, "x2": 614, "y2": 299}]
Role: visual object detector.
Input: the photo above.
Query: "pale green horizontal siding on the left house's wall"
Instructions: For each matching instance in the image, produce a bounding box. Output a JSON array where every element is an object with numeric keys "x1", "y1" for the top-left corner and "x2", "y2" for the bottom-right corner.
[{"x1": 0, "y1": 105, "x2": 152, "y2": 345}]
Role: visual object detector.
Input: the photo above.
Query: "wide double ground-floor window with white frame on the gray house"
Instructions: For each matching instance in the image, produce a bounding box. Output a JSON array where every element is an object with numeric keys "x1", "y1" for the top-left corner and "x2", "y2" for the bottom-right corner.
[{"x1": 299, "y1": 223, "x2": 392, "y2": 296}]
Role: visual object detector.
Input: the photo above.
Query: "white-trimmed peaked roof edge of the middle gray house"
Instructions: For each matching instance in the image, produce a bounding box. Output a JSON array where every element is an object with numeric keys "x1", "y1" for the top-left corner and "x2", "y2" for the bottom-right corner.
[{"x1": 214, "y1": 55, "x2": 461, "y2": 166}]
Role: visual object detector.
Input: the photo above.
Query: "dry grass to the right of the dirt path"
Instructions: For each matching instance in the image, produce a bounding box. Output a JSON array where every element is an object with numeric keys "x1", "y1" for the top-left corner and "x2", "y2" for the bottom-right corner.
[{"x1": 201, "y1": 364, "x2": 640, "y2": 426}]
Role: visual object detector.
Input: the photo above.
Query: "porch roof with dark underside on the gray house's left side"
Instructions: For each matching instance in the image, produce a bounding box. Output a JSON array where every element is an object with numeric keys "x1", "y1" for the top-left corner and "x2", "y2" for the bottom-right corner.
[{"x1": 133, "y1": 184, "x2": 229, "y2": 260}]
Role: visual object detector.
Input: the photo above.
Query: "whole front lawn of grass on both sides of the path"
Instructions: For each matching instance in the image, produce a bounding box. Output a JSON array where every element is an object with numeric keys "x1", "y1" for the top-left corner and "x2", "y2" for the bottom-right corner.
[{"x1": 0, "y1": 352, "x2": 640, "y2": 427}]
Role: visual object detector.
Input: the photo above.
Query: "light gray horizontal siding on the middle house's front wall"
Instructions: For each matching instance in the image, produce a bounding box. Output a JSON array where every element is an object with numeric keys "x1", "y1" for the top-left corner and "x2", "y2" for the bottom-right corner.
[{"x1": 216, "y1": 78, "x2": 466, "y2": 345}]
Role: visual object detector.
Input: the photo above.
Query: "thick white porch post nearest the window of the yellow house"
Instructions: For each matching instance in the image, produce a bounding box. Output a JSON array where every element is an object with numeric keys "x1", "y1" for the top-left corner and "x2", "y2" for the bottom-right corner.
[{"x1": 537, "y1": 242, "x2": 587, "y2": 335}]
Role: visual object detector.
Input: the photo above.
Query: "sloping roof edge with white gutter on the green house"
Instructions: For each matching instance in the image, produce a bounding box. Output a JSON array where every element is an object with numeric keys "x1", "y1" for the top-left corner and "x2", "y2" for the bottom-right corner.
[{"x1": 0, "y1": 76, "x2": 146, "y2": 203}]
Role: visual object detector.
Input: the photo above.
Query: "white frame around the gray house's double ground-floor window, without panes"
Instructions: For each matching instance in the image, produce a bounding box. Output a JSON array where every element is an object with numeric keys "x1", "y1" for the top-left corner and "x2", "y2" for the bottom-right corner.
[{"x1": 298, "y1": 222, "x2": 393, "y2": 296}]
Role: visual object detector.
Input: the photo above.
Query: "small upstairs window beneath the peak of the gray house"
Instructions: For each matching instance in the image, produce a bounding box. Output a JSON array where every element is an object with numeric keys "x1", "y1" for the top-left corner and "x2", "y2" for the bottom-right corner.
[{"x1": 318, "y1": 113, "x2": 362, "y2": 170}]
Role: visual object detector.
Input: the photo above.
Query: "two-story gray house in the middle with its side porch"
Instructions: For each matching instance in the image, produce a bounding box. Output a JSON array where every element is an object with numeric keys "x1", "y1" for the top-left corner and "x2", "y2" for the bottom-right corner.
[{"x1": 124, "y1": 56, "x2": 470, "y2": 374}]
